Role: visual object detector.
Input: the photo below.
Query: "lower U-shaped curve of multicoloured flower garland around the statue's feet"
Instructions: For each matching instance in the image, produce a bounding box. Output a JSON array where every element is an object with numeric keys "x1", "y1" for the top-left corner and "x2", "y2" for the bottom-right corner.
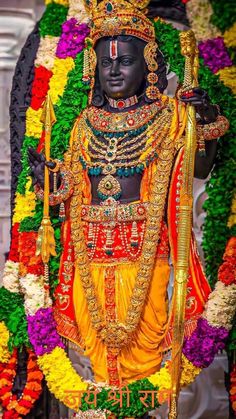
[{"x1": 0, "y1": 246, "x2": 232, "y2": 416}]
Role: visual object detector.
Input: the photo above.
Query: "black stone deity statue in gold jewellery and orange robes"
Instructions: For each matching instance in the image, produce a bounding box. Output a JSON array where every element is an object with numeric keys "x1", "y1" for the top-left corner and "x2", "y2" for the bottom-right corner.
[{"x1": 1, "y1": 0, "x2": 231, "y2": 419}]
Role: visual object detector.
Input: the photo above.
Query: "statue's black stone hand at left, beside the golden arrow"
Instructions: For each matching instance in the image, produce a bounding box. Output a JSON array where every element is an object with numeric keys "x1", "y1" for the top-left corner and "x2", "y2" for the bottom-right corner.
[{"x1": 28, "y1": 147, "x2": 56, "y2": 188}]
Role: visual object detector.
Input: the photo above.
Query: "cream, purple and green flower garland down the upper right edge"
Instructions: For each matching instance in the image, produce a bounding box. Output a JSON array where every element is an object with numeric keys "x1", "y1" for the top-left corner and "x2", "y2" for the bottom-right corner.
[{"x1": 186, "y1": 0, "x2": 236, "y2": 286}]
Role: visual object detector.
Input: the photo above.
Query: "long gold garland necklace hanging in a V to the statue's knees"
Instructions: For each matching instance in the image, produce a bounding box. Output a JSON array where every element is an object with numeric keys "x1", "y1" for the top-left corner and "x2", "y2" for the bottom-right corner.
[{"x1": 70, "y1": 101, "x2": 174, "y2": 353}]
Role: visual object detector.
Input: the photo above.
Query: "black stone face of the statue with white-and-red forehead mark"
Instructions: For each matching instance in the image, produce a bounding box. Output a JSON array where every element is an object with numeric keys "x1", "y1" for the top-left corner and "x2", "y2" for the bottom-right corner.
[{"x1": 96, "y1": 38, "x2": 146, "y2": 99}]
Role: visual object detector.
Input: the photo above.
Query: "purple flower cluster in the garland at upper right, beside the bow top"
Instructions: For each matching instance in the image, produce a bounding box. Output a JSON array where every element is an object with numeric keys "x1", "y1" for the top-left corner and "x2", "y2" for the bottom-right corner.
[{"x1": 198, "y1": 36, "x2": 233, "y2": 73}]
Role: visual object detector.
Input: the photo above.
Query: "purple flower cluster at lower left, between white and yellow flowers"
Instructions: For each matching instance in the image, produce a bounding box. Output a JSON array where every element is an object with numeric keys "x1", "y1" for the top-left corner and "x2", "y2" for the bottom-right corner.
[{"x1": 27, "y1": 308, "x2": 64, "y2": 356}]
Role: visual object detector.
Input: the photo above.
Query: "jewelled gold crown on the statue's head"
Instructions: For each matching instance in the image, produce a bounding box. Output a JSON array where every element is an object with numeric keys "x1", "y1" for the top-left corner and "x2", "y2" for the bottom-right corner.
[{"x1": 90, "y1": 0, "x2": 155, "y2": 44}]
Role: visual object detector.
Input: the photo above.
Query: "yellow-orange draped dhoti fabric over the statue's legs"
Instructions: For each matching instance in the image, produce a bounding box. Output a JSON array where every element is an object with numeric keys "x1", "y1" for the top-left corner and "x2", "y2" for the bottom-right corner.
[{"x1": 73, "y1": 259, "x2": 170, "y2": 383}]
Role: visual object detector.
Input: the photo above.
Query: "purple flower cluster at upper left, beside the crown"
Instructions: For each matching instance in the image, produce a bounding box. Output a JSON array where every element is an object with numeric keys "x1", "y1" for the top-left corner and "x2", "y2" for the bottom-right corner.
[{"x1": 56, "y1": 17, "x2": 89, "y2": 58}]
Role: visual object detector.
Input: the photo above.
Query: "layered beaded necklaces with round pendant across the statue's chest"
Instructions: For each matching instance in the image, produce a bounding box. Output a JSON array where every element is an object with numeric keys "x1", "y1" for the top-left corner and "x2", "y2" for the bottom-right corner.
[{"x1": 78, "y1": 104, "x2": 172, "y2": 200}]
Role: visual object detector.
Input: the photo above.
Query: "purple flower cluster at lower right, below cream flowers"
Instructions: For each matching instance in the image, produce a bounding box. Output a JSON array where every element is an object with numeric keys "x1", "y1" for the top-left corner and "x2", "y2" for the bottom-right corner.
[{"x1": 183, "y1": 318, "x2": 228, "y2": 368}]
